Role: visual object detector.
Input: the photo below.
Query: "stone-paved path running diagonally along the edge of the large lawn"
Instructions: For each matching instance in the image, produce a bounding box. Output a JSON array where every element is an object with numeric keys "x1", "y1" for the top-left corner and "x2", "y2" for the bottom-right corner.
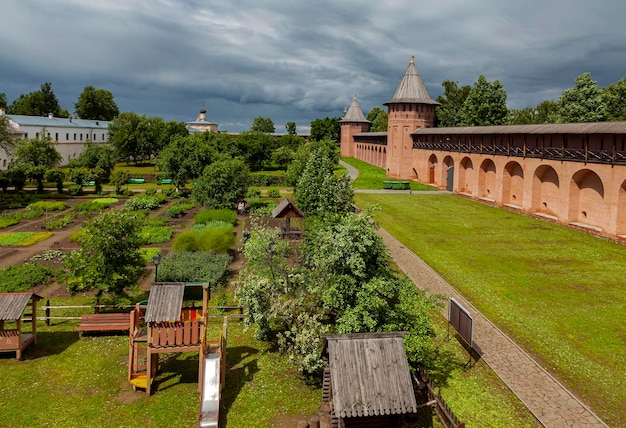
[{"x1": 378, "y1": 228, "x2": 607, "y2": 427}]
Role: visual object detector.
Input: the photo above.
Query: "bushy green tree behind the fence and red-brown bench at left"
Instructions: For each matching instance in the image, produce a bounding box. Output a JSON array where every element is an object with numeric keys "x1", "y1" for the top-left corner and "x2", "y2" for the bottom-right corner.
[{"x1": 63, "y1": 210, "x2": 144, "y2": 295}]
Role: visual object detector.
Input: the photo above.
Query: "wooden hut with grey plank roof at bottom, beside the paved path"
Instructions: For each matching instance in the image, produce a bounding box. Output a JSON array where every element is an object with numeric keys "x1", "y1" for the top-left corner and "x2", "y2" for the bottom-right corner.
[{"x1": 324, "y1": 332, "x2": 417, "y2": 428}]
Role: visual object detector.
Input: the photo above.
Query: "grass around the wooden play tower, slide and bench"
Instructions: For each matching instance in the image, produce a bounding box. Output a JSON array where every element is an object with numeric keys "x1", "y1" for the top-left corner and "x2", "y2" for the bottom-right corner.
[{"x1": 0, "y1": 297, "x2": 321, "y2": 428}]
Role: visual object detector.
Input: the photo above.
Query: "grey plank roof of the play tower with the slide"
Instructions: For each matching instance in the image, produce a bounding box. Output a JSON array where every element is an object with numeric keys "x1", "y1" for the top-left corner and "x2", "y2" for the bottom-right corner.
[{"x1": 145, "y1": 282, "x2": 185, "y2": 323}]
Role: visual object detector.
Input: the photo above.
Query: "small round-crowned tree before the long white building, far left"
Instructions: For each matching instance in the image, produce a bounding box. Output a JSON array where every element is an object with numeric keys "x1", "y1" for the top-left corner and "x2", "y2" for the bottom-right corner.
[{"x1": 14, "y1": 135, "x2": 61, "y2": 193}]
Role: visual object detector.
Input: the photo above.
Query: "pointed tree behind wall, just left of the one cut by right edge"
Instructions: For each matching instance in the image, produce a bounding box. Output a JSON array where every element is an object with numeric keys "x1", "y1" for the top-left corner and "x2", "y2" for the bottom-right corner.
[{"x1": 556, "y1": 72, "x2": 606, "y2": 123}]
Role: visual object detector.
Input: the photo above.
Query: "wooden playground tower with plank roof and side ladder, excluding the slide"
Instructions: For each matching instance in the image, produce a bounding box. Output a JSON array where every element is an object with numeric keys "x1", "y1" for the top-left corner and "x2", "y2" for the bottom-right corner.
[{"x1": 128, "y1": 282, "x2": 209, "y2": 394}]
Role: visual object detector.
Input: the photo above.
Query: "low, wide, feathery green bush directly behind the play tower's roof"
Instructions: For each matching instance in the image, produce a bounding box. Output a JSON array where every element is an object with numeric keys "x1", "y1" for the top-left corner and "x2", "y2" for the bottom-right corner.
[{"x1": 154, "y1": 251, "x2": 231, "y2": 289}]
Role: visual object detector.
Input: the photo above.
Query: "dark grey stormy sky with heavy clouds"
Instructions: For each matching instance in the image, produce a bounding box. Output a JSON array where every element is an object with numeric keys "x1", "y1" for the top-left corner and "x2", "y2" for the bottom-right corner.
[{"x1": 0, "y1": 0, "x2": 626, "y2": 132}]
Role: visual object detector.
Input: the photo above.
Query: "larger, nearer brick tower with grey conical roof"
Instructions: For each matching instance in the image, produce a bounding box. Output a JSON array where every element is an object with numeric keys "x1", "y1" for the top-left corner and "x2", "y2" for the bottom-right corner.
[{"x1": 383, "y1": 57, "x2": 439, "y2": 179}]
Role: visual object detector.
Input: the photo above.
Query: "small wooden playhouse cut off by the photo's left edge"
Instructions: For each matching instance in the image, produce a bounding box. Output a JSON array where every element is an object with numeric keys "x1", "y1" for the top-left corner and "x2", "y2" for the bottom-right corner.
[{"x1": 0, "y1": 293, "x2": 41, "y2": 360}]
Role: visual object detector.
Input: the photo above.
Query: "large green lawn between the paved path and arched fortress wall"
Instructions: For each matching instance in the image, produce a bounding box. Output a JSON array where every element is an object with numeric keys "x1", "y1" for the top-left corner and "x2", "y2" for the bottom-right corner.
[{"x1": 355, "y1": 194, "x2": 626, "y2": 426}]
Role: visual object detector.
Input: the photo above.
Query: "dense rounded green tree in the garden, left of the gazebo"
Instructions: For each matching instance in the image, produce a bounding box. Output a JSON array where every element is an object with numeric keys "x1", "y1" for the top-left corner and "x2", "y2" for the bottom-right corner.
[{"x1": 191, "y1": 159, "x2": 250, "y2": 208}]
